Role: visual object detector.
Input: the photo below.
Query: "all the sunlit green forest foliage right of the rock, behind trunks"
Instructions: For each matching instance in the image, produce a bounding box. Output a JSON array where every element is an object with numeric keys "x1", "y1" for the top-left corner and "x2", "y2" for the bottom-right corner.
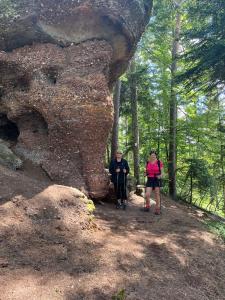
[{"x1": 117, "y1": 0, "x2": 225, "y2": 216}]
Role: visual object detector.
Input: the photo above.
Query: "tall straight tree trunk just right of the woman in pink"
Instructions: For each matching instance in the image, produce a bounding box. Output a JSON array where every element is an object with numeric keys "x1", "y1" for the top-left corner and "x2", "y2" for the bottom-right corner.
[{"x1": 168, "y1": 10, "x2": 181, "y2": 200}]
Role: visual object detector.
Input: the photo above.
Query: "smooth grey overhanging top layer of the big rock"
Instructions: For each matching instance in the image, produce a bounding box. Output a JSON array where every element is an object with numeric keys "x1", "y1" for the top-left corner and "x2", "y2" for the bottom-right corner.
[{"x1": 0, "y1": 0, "x2": 152, "y2": 83}]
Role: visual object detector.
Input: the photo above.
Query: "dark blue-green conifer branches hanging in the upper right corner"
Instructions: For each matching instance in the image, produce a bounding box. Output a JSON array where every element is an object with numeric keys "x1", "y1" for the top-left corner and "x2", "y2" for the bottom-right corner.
[{"x1": 179, "y1": 0, "x2": 225, "y2": 92}]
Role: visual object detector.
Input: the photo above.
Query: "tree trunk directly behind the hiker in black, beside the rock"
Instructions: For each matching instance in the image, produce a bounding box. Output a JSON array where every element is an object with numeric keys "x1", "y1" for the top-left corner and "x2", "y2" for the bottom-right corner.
[{"x1": 111, "y1": 79, "x2": 121, "y2": 159}]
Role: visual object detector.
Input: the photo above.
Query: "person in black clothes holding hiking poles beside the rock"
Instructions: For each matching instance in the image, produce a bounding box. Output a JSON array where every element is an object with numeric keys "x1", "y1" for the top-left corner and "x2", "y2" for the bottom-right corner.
[{"x1": 109, "y1": 150, "x2": 130, "y2": 209}]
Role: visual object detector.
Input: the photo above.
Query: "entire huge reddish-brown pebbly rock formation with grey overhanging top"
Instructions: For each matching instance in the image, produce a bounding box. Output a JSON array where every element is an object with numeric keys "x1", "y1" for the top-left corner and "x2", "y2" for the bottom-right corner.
[{"x1": 0, "y1": 0, "x2": 151, "y2": 198}]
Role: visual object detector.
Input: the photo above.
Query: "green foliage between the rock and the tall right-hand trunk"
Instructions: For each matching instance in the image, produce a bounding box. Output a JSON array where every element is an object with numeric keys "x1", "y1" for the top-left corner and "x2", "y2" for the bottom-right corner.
[{"x1": 120, "y1": 0, "x2": 178, "y2": 180}]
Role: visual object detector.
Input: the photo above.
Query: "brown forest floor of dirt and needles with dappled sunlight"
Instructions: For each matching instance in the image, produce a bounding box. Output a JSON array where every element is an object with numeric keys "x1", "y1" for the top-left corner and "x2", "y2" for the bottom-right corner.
[{"x1": 0, "y1": 167, "x2": 225, "y2": 300}]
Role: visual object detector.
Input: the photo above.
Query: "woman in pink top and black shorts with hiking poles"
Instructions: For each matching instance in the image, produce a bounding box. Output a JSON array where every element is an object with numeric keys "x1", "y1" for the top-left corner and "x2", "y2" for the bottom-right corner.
[{"x1": 144, "y1": 151, "x2": 163, "y2": 215}]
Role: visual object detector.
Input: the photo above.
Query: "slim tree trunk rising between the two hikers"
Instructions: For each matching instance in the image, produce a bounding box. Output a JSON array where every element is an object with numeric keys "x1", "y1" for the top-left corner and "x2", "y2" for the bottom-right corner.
[{"x1": 130, "y1": 59, "x2": 140, "y2": 184}]
